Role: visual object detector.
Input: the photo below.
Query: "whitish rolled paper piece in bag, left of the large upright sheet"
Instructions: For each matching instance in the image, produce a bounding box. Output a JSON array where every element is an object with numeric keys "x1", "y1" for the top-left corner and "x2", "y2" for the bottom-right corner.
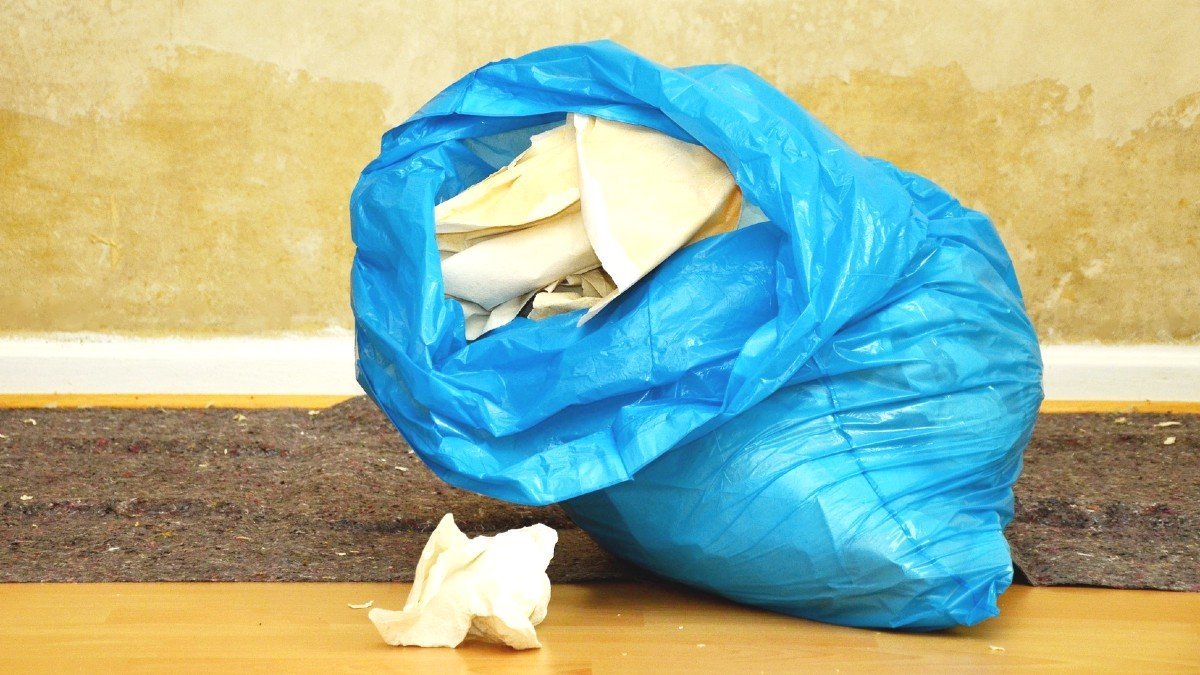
[{"x1": 442, "y1": 207, "x2": 600, "y2": 310}]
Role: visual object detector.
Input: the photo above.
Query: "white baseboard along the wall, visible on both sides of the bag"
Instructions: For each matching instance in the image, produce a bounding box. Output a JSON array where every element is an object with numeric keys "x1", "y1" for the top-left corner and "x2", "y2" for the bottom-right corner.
[{"x1": 0, "y1": 333, "x2": 1200, "y2": 401}]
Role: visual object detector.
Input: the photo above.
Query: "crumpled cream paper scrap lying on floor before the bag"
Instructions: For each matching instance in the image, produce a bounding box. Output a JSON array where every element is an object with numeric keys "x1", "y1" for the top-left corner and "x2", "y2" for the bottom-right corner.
[{"x1": 367, "y1": 514, "x2": 558, "y2": 650}]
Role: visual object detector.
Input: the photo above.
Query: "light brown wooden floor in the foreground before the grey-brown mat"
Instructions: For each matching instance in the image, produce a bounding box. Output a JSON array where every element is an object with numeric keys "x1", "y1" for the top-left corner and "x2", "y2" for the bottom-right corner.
[{"x1": 0, "y1": 584, "x2": 1200, "y2": 674}]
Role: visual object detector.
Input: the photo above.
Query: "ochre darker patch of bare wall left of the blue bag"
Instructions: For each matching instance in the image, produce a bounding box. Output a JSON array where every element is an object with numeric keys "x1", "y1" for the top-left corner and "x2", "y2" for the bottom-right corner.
[{"x1": 0, "y1": 49, "x2": 386, "y2": 334}]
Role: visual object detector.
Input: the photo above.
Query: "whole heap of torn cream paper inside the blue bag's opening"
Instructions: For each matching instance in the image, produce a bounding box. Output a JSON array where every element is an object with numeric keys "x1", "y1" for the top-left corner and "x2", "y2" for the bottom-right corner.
[{"x1": 434, "y1": 114, "x2": 742, "y2": 340}]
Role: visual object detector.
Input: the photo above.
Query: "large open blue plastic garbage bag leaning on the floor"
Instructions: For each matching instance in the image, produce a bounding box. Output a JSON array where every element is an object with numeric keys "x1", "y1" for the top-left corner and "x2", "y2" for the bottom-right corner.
[{"x1": 350, "y1": 42, "x2": 1042, "y2": 629}]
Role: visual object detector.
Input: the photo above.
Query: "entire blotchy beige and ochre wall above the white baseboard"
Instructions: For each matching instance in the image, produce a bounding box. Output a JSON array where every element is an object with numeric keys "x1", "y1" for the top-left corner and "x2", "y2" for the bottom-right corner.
[{"x1": 0, "y1": 0, "x2": 1200, "y2": 336}]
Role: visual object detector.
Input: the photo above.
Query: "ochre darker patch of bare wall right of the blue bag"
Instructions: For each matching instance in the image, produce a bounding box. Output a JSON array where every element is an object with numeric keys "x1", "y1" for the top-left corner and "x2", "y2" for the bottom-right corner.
[{"x1": 788, "y1": 66, "x2": 1200, "y2": 342}]
